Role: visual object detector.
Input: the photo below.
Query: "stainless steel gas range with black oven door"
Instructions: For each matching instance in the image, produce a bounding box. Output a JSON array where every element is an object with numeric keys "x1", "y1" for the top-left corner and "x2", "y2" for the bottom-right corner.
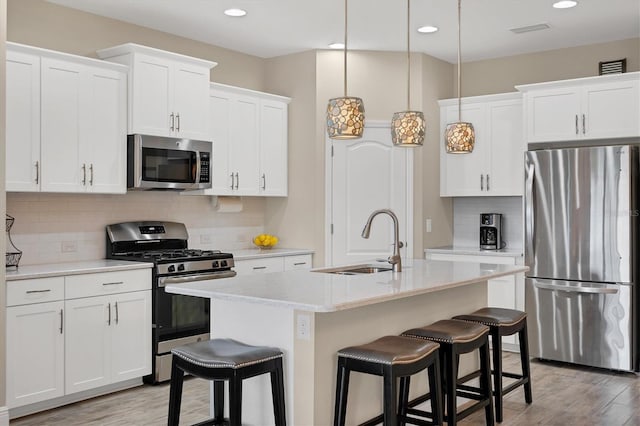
[{"x1": 107, "y1": 221, "x2": 236, "y2": 383}]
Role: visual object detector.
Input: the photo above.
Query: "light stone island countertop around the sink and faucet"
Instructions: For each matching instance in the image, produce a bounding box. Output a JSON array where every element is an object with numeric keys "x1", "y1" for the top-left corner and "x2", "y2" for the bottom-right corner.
[{"x1": 165, "y1": 259, "x2": 528, "y2": 312}]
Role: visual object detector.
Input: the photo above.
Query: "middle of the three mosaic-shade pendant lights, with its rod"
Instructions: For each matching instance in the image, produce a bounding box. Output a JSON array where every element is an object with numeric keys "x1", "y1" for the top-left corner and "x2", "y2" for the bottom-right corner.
[{"x1": 391, "y1": 0, "x2": 425, "y2": 148}]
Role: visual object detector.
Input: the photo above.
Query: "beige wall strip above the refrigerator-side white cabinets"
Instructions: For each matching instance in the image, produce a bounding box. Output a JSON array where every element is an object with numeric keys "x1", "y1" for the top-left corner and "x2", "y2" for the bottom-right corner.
[{"x1": 454, "y1": 38, "x2": 640, "y2": 96}]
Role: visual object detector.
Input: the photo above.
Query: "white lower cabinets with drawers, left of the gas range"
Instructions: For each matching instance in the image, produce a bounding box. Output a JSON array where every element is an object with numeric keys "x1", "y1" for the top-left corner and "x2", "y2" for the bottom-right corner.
[{"x1": 6, "y1": 269, "x2": 151, "y2": 408}]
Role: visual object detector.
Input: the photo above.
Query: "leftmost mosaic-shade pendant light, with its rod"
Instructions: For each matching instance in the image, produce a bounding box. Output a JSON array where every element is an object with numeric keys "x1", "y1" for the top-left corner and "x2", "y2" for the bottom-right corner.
[{"x1": 327, "y1": 0, "x2": 364, "y2": 139}]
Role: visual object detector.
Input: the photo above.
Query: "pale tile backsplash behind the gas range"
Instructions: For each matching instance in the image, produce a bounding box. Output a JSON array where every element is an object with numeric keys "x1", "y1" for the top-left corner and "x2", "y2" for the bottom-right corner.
[{"x1": 7, "y1": 191, "x2": 264, "y2": 265}]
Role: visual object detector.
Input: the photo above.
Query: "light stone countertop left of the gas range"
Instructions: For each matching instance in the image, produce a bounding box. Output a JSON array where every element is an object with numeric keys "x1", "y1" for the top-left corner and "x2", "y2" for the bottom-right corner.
[{"x1": 6, "y1": 259, "x2": 153, "y2": 281}]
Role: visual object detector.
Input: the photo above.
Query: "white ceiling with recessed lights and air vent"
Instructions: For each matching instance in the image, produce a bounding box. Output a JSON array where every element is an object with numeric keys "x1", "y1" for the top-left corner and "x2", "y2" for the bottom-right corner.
[{"x1": 49, "y1": 0, "x2": 640, "y2": 63}]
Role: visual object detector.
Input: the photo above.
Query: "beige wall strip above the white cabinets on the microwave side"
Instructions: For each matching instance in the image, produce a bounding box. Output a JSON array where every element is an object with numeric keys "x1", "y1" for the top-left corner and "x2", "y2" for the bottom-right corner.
[{"x1": 7, "y1": 0, "x2": 264, "y2": 90}]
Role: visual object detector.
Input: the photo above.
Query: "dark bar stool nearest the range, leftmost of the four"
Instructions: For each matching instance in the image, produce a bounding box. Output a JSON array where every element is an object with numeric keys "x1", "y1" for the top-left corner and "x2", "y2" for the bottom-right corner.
[{"x1": 167, "y1": 339, "x2": 286, "y2": 426}]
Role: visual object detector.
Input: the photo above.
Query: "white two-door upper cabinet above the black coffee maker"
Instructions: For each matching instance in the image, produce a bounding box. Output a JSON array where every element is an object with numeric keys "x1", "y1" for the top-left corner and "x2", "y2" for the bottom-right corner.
[{"x1": 439, "y1": 93, "x2": 525, "y2": 197}]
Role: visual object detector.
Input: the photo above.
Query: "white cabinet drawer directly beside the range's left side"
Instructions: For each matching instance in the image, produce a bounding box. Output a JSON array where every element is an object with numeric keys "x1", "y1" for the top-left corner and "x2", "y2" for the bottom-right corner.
[{"x1": 65, "y1": 269, "x2": 151, "y2": 299}]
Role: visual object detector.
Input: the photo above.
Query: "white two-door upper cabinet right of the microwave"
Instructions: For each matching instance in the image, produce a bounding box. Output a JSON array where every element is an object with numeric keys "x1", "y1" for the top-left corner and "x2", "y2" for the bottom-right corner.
[{"x1": 204, "y1": 83, "x2": 290, "y2": 196}]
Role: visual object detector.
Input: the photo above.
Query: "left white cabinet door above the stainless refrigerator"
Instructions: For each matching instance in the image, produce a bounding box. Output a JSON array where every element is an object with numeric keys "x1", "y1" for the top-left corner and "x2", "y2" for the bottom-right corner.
[{"x1": 525, "y1": 87, "x2": 581, "y2": 142}]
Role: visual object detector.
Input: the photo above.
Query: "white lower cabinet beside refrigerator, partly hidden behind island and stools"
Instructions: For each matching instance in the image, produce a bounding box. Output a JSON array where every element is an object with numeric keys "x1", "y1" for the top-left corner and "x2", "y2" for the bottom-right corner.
[{"x1": 426, "y1": 253, "x2": 524, "y2": 350}]
